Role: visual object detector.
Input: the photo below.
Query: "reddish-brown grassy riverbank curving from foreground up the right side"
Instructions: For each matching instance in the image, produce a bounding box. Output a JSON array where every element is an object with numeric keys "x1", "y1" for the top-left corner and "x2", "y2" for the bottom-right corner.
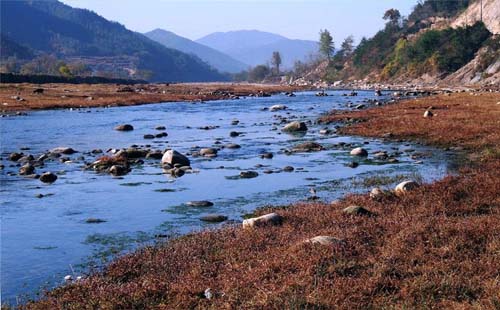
[{"x1": 20, "y1": 93, "x2": 500, "y2": 309}]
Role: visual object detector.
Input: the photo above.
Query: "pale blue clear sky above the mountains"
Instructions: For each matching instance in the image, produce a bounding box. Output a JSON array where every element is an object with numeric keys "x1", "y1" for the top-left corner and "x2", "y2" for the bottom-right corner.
[{"x1": 62, "y1": 0, "x2": 417, "y2": 42}]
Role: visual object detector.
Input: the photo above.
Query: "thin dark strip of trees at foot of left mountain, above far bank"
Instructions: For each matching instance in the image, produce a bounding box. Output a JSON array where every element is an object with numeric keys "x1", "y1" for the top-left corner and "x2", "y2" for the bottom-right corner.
[{"x1": 0, "y1": 73, "x2": 147, "y2": 85}]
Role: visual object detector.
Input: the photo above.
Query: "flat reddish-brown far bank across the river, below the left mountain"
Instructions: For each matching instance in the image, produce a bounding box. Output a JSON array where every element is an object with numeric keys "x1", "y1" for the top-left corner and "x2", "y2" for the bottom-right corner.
[{"x1": 0, "y1": 83, "x2": 304, "y2": 113}]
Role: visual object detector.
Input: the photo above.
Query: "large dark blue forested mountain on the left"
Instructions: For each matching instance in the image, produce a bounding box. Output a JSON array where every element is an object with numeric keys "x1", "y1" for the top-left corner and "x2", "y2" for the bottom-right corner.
[{"x1": 0, "y1": 0, "x2": 225, "y2": 82}]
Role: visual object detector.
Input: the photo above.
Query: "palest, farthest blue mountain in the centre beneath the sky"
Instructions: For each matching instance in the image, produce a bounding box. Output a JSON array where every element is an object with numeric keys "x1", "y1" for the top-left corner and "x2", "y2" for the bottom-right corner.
[{"x1": 196, "y1": 30, "x2": 318, "y2": 68}]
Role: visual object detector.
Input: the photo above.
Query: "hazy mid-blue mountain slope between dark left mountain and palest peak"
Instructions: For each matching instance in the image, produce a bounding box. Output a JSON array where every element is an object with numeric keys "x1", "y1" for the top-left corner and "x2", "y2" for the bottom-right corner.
[{"x1": 144, "y1": 29, "x2": 248, "y2": 73}]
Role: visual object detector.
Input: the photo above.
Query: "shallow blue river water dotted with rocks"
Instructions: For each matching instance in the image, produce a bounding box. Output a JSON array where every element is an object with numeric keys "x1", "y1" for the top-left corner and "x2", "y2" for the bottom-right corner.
[{"x1": 0, "y1": 91, "x2": 458, "y2": 305}]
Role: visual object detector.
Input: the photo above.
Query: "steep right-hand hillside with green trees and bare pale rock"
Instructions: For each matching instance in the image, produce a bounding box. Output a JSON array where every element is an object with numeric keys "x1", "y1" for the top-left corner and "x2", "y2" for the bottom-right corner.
[{"x1": 302, "y1": 0, "x2": 500, "y2": 86}]
